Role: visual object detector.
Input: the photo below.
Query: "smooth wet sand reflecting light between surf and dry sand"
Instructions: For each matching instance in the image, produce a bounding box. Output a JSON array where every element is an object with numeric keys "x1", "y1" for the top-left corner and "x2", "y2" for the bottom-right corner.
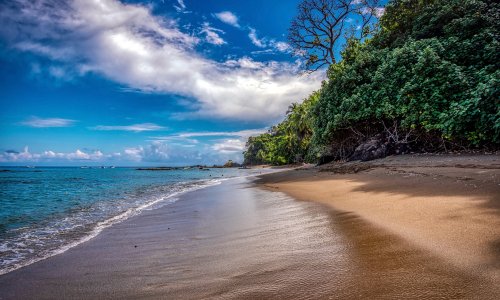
[{"x1": 0, "y1": 162, "x2": 500, "y2": 299}]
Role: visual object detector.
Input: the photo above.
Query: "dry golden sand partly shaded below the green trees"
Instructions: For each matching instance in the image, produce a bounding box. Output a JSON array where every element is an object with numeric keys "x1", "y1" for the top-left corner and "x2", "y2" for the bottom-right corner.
[{"x1": 259, "y1": 155, "x2": 500, "y2": 285}]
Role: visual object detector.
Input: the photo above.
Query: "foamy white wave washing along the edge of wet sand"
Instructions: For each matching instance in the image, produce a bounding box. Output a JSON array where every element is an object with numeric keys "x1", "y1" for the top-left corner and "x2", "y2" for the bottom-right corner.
[{"x1": 0, "y1": 178, "x2": 223, "y2": 275}]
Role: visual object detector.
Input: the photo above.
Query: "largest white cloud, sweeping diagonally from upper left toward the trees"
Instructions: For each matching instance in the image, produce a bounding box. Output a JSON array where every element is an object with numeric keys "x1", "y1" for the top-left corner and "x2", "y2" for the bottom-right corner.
[{"x1": 0, "y1": 0, "x2": 324, "y2": 122}]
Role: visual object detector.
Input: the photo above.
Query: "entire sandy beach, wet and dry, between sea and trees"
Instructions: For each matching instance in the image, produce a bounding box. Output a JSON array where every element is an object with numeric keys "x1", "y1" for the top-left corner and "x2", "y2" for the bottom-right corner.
[{"x1": 0, "y1": 157, "x2": 500, "y2": 299}]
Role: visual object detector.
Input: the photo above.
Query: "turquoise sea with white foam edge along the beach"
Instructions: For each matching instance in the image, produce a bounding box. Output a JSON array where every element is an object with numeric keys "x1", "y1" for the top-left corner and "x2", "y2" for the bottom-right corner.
[{"x1": 0, "y1": 167, "x2": 262, "y2": 274}]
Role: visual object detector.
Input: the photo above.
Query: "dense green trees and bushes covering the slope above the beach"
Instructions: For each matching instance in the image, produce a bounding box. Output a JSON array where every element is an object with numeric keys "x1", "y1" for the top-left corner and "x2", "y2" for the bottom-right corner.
[{"x1": 244, "y1": 0, "x2": 500, "y2": 164}]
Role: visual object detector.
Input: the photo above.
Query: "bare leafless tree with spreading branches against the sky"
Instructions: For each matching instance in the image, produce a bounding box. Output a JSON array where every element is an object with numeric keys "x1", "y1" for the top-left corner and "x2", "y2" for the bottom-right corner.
[{"x1": 288, "y1": 0, "x2": 382, "y2": 72}]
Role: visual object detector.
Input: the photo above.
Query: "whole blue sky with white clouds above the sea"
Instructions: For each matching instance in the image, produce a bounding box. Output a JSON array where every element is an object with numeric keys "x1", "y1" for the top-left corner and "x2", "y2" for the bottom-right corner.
[{"x1": 0, "y1": 0, "x2": 378, "y2": 166}]
